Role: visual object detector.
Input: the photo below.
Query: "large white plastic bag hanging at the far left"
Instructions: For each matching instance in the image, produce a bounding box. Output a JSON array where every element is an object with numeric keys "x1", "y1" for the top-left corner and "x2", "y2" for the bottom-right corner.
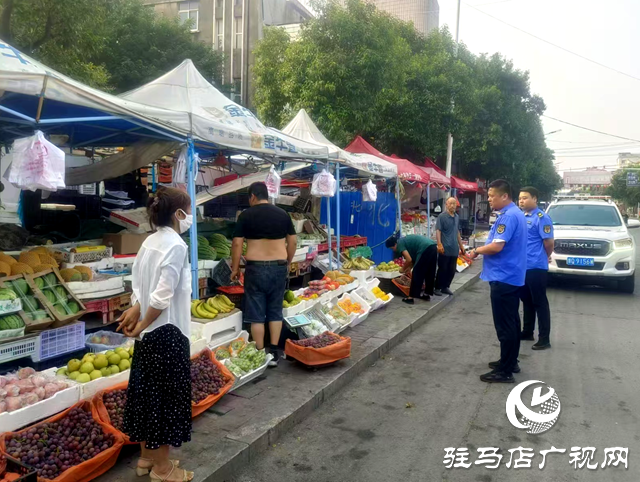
[{"x1": 5, "y1": 131, "x2": 66, "y2": 191}]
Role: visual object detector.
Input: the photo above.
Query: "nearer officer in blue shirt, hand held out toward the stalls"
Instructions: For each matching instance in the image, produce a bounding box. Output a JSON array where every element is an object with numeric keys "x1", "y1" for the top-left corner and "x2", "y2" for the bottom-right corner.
[{"x1": 470, "y1": 179, "x2": 527, "y2": 383}]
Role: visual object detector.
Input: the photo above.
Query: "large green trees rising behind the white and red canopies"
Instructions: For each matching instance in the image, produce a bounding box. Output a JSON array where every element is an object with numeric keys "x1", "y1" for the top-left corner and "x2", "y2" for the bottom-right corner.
[{"x1": 254, "y1": 0, "x2": 561, "y2": 197}]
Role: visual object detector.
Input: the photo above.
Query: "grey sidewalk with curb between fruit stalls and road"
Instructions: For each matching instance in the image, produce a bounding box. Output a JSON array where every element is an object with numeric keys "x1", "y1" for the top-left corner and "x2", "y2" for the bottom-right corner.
[{"x1": 96, "y1": 261, "x2": 482, "y2": 482}]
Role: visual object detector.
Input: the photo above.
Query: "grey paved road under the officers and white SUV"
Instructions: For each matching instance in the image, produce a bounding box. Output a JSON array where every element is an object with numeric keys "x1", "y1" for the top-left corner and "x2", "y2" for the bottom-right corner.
[{"x1": 234, "y1": 232, "x2": 640, "y2": 482}]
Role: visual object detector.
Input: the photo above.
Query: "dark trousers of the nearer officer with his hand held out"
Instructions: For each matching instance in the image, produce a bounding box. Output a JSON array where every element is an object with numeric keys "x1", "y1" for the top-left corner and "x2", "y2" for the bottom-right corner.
[{"x1": 489, "y1": 281, "x2": 522, "y2": 375}]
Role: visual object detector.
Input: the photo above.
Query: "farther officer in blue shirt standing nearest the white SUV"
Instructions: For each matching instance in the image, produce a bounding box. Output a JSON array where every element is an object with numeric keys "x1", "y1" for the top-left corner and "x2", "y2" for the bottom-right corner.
[{"x1": 519, "y1": 187, "x2": 553, "y2": 350}]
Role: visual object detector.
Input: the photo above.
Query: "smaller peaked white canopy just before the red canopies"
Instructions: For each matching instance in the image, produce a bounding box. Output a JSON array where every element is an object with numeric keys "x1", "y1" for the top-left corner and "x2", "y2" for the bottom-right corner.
[{"x1": 282, "y1": 109, "x2": 398, "y2": 177}]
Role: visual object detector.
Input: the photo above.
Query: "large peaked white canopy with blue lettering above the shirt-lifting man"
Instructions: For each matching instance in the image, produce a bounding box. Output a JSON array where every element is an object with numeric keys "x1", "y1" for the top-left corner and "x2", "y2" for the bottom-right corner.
[{"x1": 121, "y1": 59, "x2": 328, "y2": 159}]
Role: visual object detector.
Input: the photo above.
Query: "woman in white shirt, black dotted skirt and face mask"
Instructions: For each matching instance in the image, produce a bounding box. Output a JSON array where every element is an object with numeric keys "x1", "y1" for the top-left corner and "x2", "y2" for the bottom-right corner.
[{"x1": 118, "y1": 188, "x2": 193, "y2": 482}]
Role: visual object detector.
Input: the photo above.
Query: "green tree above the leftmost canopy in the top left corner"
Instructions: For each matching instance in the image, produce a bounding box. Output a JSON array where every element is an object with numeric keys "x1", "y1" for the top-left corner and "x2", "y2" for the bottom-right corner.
[{"x1": 0, "y1": 0, "x2": 222, "y2": 92}]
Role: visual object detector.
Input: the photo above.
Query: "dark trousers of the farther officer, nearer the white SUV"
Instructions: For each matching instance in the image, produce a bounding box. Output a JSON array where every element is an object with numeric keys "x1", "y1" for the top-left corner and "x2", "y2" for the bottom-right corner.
[{"x1": 520, "y1": 269, "x2": 551, "y2": 339}]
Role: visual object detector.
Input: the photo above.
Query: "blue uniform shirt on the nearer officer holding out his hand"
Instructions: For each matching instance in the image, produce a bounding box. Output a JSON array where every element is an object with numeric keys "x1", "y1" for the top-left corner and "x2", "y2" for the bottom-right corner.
[{"x1": 480, "y1": 203, "x2": 527, "y2": 286}]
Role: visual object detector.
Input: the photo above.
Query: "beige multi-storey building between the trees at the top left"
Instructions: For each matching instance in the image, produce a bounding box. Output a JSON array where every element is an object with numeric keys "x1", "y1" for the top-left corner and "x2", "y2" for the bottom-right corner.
[{"x1": 143, "y1": 0, "x2": 311, "y2": 108}]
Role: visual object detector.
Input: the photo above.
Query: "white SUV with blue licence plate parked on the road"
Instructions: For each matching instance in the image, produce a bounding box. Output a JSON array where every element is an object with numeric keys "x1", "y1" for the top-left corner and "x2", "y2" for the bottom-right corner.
[{"x1": 547, "y1": 196, "x2": 640, "y2": 293}]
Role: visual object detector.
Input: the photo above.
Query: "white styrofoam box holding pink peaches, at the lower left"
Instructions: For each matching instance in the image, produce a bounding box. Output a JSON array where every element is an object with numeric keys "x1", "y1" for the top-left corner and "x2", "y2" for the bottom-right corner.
[{"x1": 0, "y1": 368, "x2": 80, "y2": 432}]
